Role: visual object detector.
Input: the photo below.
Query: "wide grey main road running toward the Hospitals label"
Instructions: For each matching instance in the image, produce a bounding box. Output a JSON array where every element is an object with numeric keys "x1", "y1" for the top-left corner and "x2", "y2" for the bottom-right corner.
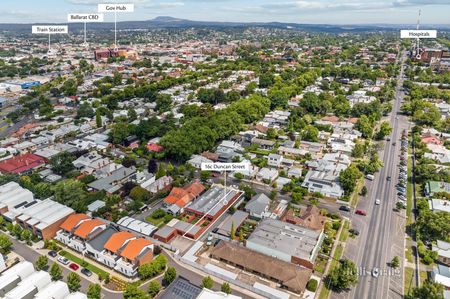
[{"x1": 332, "y1": 53, "x2": 408, "y2": 299}]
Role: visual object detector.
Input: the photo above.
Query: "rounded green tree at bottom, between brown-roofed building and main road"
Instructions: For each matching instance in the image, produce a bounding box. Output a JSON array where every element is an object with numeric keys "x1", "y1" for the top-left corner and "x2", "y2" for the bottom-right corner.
[{"x1": 326, "y1": 259, "x2": 358, "y2": 292}]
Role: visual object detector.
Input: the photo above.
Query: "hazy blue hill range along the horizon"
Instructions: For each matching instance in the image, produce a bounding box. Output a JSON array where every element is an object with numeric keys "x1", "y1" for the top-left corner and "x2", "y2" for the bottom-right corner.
[{"x1": 0, "y1": 16, "x2": 450, "y2": 33}]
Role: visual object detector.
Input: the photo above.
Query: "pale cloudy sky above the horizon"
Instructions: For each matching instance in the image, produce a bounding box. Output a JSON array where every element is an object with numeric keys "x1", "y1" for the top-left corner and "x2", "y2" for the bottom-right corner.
[{"x1": 0, "y1": 0, "x2": 450, "y2": 24}]
